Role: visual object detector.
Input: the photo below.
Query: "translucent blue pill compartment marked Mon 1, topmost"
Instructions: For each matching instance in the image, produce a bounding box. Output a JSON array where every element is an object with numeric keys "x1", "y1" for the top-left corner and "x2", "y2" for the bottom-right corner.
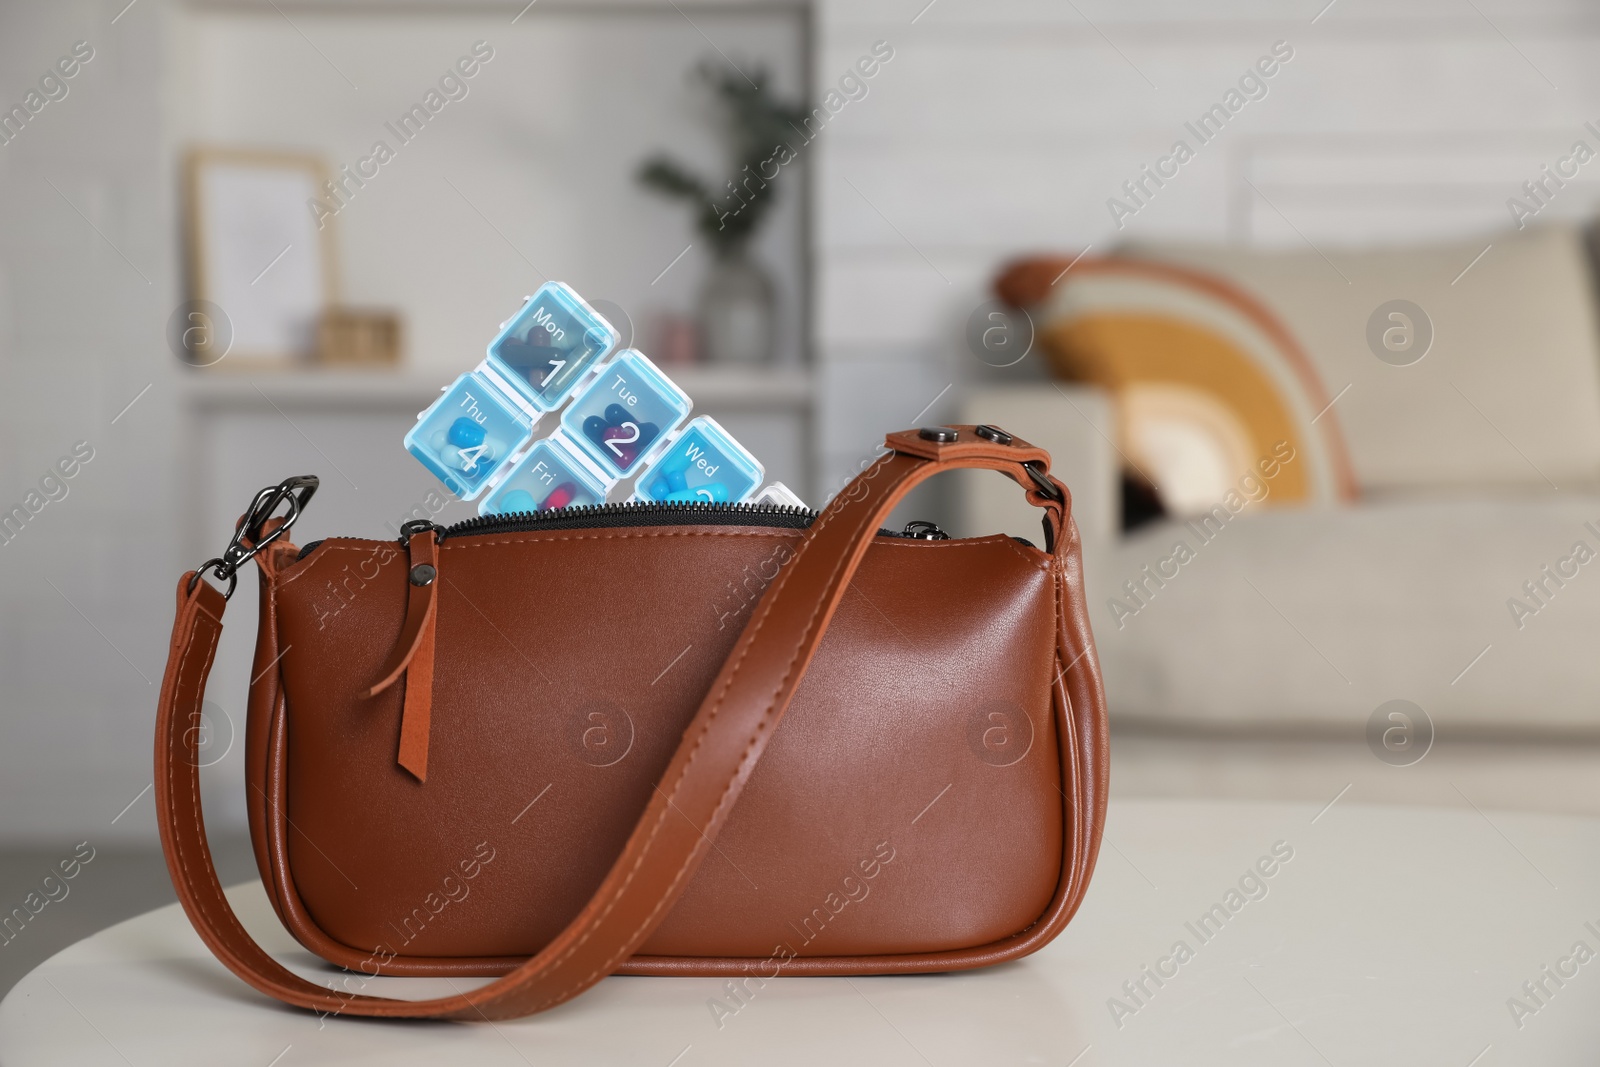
[{"x1": 488, "y1": 282, "x2": 621, "y2": 411}]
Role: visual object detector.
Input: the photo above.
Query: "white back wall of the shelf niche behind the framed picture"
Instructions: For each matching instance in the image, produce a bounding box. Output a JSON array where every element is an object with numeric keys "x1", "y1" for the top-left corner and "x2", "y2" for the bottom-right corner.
[{"x1": 170, "y1": 3, "x2": 805, "y2": 376}]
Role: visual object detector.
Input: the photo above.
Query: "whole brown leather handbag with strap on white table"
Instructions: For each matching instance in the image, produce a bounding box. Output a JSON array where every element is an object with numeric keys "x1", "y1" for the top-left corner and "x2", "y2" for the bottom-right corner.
[{"x1": 155, "y1": 426, "x2": 1107, "y2": 1019}]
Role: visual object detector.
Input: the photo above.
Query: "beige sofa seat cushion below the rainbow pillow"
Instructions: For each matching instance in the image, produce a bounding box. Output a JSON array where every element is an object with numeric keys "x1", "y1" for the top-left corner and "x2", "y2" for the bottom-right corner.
[{"x1": 1083, "y1": 490, "x2": 1600, "y2": 729}]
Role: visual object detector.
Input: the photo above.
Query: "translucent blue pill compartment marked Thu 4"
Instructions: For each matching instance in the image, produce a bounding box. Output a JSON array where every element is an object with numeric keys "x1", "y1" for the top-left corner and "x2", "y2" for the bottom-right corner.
[{"x1": 405, "y1": 371, "x2": 536, "y2": 501}]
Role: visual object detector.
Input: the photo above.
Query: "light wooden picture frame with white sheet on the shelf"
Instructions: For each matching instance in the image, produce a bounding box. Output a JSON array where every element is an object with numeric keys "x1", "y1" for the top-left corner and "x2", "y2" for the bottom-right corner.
[{"x1": 182, "y1": 146, "x2": 339, "y2": 371}]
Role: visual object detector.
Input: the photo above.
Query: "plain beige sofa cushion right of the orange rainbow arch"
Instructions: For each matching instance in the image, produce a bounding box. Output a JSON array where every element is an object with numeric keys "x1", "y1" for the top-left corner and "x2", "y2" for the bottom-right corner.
[{"x1": 1126, "y1": 227, "x2": 1600, "y2": 491}]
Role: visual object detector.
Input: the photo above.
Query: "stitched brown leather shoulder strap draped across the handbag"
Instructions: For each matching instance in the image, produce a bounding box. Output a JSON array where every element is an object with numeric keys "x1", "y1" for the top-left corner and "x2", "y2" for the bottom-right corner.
[{"x1": 155, "y1": 427, "x2": 1104, "y2": 1019}]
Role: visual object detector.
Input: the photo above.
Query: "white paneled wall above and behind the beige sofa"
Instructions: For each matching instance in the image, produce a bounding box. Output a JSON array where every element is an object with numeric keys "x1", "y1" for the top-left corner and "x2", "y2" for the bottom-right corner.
[{"x1": 814, "y1": 0, "x2": 1600, "y2": 506}]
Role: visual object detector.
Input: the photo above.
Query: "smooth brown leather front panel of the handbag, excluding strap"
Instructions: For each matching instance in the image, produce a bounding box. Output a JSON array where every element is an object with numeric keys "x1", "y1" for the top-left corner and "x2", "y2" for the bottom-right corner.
[{"x1": 278, "y1": 526, "x2": 1061, "y2": 961}]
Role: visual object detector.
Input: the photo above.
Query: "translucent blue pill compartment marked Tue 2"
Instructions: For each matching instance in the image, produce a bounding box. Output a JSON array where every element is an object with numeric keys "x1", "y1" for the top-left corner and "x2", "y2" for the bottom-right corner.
[{"x1": 562, "y1": 349, "x2": 693, "y2": 478}]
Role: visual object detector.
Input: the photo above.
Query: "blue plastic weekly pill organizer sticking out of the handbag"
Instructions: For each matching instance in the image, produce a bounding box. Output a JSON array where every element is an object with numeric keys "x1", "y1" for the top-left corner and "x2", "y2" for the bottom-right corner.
[{"x1": 405, "y1": 282, "x2": 805, "y2": 515}]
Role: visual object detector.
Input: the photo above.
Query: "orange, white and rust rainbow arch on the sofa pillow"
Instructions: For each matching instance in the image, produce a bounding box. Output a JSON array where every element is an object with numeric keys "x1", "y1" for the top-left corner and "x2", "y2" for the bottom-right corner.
[{"x1": 997, "y1": 258, "x2": 1357, "y2": 515}]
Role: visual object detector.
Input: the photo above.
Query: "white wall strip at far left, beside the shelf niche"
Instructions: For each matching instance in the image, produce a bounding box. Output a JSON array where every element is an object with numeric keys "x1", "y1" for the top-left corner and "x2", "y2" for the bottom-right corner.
[{"x1": 0, "y1": 2, "x2": 179, "y2": 843}]
